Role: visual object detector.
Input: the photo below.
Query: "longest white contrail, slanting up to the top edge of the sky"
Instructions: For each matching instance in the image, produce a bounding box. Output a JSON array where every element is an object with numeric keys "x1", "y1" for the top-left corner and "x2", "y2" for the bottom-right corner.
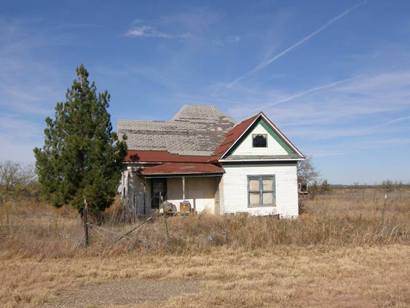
[{"x1": 227, "y1": 0, "x2": 367, "y2": 88}]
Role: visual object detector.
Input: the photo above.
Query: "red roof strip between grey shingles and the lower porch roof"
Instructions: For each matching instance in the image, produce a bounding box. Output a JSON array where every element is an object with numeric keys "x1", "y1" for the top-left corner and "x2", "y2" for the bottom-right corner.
[{"x1": 125, "y1": 150, "x2": 213, "y2": 163}]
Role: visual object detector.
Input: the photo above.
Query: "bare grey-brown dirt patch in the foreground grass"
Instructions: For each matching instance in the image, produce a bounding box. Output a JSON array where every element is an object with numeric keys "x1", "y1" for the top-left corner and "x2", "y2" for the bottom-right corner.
[{"x1": 44, "y1": 279, "x2": 198, "y2": 307}]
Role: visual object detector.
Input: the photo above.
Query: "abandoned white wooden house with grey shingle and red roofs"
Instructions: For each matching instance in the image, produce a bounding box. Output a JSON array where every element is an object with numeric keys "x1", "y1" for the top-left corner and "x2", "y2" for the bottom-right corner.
[{"x1": 118, "y1": 105, "x2": 304, "y2": 217}]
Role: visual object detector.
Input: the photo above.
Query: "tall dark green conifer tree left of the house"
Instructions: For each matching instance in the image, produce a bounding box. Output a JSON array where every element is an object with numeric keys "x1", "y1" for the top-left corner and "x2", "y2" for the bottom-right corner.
[{"x1": 34, "y1": 65, "x2": 127, "y2": 215}]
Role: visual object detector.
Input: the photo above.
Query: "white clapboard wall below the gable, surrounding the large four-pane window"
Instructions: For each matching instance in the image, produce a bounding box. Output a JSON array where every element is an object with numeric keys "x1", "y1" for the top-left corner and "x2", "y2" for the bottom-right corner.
[{"x1": 221, "y1": 163, "x2": 298, "y2": 217}]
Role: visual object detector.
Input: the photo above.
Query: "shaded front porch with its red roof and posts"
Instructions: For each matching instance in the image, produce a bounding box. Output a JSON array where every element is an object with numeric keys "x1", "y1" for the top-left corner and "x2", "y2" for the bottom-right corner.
[{"x1": 124, "y1": 163, "x2": 223, "y2": 216}]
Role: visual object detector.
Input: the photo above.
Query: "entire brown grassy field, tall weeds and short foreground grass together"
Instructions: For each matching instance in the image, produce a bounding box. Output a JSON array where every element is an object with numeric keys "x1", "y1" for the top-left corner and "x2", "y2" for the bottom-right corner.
[{"x1": 0, "y1": 188, "x2": 410, "y2": 307}]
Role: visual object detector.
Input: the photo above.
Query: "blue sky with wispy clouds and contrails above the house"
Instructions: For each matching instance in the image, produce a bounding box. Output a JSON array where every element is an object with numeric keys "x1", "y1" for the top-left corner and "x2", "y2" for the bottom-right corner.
[{"x1": 0, "y1": 0, "x2": 410, "y2": 183}]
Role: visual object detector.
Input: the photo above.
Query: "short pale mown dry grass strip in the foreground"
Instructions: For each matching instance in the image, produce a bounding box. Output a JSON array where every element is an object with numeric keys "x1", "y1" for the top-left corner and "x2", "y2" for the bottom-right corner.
[{"x1": 0, "y1": 245, "x2": 410, "y2": 307}]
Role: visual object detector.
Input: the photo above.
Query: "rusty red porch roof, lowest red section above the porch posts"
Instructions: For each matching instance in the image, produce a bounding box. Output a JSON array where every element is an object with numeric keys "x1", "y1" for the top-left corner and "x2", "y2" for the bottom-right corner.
[{"x1": 141, "y1": 163, "x2": 224, "y2": 175}]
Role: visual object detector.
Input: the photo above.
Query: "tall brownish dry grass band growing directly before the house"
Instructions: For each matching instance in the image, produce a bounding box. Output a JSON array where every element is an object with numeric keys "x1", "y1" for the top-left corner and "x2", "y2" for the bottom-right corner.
[{"x1": 0, "y1": 189, "x2": 410, "y2": 257}]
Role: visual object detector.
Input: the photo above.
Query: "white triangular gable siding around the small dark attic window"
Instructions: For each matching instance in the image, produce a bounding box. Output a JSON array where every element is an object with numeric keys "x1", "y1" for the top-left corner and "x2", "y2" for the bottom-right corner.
[{"x1": 232, "y1": 123, "x2": 288, "y2": 155}]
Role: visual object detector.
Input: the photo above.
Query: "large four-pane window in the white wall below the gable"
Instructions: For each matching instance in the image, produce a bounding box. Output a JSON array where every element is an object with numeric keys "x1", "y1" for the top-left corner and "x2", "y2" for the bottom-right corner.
[{"x1": 248, "y1": 175, "x2": 276, "y2": 207}]
